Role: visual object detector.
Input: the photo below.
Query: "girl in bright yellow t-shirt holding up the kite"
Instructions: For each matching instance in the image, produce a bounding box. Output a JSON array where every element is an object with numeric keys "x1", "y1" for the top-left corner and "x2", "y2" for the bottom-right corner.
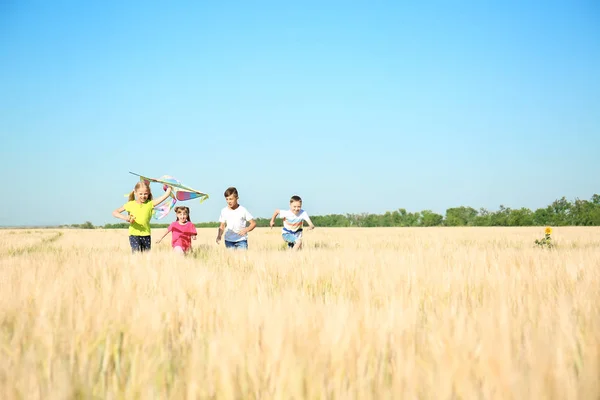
[{"x1": 113, "y1": 181, "x2": 171, "y2": 253}]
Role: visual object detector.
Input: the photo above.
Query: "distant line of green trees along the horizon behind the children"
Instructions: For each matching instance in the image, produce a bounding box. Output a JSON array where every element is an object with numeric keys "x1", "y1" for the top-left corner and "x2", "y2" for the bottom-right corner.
[{"x1": 86, "y1": 194, "x2": 600, "y2": 229}]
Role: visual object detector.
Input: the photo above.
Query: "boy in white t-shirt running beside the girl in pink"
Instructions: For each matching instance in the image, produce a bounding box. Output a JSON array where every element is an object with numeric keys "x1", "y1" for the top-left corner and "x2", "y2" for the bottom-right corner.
[{"x1": 217, "y1": 187, "x2": 256, "y2": 249}]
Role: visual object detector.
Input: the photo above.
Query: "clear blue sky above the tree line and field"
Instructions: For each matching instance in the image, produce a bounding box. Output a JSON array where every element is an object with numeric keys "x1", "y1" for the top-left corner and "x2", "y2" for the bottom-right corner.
[{"x1": 0, "y1": 0, "x2": 600, "y2": 225}]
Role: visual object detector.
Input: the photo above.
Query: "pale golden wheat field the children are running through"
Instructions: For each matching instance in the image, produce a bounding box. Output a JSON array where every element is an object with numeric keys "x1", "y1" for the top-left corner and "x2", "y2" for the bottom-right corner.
[{"x1": 0, "y1": 228, "x2": 600, "y2": 399}]
